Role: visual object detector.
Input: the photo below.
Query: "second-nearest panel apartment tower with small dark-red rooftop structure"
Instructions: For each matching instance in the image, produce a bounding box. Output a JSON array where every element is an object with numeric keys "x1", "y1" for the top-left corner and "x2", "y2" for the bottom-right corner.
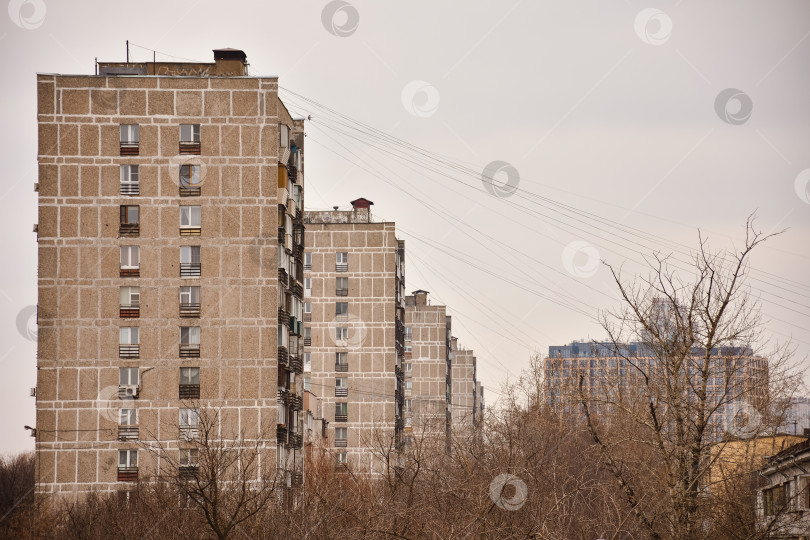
[{"x1": 304, "y1": 199, "x2": 405, "y2": 474}]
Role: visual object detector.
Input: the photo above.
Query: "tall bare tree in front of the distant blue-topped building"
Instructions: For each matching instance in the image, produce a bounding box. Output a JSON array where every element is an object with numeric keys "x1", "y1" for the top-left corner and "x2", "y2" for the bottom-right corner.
[{"x1": 578, "y1": 219, "x2": 796, "y2": 539}]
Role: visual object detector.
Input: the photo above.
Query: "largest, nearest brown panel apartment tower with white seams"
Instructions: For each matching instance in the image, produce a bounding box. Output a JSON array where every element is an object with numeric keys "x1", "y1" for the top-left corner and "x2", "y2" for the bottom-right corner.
[{"x1": 36, "y1": 49, "x2": 304, "y2": 494}]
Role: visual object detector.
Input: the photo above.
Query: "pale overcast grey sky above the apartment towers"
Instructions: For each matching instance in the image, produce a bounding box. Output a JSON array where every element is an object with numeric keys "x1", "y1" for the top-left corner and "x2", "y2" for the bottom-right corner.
[{"x1": 0, "y1": 0, "x2": 810, "y2": 452}]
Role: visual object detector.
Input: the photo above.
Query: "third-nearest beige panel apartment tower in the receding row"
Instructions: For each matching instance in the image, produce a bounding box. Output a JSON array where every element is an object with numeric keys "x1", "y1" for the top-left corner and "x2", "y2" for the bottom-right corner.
[{"x1": 404, "y1": 290, "x2": 452, "y2": 440}]
